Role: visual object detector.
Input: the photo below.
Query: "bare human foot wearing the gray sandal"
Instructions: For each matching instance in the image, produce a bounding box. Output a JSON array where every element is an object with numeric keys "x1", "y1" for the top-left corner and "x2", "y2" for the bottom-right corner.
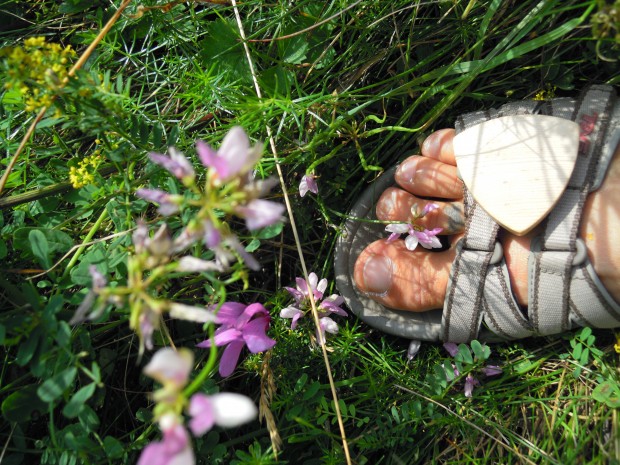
[{"x1": 353, "y1": 129, "x2": 620, "y2": 312}]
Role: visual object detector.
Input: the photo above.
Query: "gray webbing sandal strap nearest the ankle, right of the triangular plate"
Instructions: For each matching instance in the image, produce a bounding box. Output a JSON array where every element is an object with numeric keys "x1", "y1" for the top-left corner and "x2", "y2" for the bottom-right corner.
[{"x1": 528, "y1": 86, "x2": 620, "y2": 335}]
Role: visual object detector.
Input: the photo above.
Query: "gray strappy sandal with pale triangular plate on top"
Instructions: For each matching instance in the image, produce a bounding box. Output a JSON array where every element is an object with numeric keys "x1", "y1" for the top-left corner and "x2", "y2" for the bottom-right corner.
[{"x1": 335, "y1": 85, "x2": 620, "y2": 343}]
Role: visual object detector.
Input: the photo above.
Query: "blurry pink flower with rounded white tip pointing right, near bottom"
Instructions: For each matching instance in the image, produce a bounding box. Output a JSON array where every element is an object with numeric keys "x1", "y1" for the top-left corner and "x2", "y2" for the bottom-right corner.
[{"x1": 188, "y1": 392, "x2": 258, "y2": 436}]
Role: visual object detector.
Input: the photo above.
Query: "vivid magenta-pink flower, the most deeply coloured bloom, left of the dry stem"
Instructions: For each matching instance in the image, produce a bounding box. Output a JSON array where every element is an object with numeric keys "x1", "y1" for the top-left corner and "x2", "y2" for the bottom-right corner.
[{"x1": 197, "y1": 302, "x2": 276, "y2": 377}]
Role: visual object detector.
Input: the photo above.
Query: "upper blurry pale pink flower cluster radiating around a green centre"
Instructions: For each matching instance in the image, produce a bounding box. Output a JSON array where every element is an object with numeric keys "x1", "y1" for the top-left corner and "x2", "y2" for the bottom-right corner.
[{"x1": 136, "y1": 127, "x2": 285, "y2": 270}]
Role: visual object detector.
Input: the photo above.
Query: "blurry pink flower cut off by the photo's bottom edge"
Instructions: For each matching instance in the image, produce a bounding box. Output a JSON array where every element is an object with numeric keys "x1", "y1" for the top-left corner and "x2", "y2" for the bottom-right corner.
[{"x1": 138, "y1": 415, "x2": 196, "y2": 465}]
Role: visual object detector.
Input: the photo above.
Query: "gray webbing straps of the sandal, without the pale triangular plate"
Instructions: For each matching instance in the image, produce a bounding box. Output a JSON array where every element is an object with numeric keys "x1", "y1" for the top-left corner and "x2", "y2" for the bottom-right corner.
[{"x1": 442, "y1": 86, "x2": 620, "y2": 342}]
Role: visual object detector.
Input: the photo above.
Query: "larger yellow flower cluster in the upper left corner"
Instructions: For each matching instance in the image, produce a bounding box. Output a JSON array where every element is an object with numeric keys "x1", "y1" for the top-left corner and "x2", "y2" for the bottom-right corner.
[{"x1": 0, "y1": 37, "x2": 76, "y2": 111}]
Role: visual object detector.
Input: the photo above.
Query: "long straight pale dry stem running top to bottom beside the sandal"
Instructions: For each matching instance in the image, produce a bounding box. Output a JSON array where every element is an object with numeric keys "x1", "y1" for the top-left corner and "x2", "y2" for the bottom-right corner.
[{"x1": 232, "y1": 0, "x2": 352, "y2": 465}]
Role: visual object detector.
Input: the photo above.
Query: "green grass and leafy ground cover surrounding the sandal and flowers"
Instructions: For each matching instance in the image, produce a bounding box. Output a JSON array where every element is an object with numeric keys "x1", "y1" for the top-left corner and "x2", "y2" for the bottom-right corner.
[{"x1": 0, "y1": 0, "x2": 620, "y2": 464}]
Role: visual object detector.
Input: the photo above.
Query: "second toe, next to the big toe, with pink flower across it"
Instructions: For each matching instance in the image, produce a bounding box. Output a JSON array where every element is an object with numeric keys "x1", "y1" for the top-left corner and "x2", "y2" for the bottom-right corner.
[{"x1": 377, "y1": 187, "x2": 464, "y2": 234}]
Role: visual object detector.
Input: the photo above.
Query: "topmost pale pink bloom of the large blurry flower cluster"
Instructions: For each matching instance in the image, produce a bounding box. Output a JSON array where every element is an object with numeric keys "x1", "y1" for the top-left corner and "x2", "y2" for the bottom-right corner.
[{"x1": 196, "y1": 126, "x2": 263, "y2": 182}]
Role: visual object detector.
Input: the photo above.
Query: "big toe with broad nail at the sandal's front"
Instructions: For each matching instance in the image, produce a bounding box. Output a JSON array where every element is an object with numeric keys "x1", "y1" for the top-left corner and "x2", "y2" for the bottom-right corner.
[{"x1": 353, "y1": 239, "x2": 454, "y2": 312}]
